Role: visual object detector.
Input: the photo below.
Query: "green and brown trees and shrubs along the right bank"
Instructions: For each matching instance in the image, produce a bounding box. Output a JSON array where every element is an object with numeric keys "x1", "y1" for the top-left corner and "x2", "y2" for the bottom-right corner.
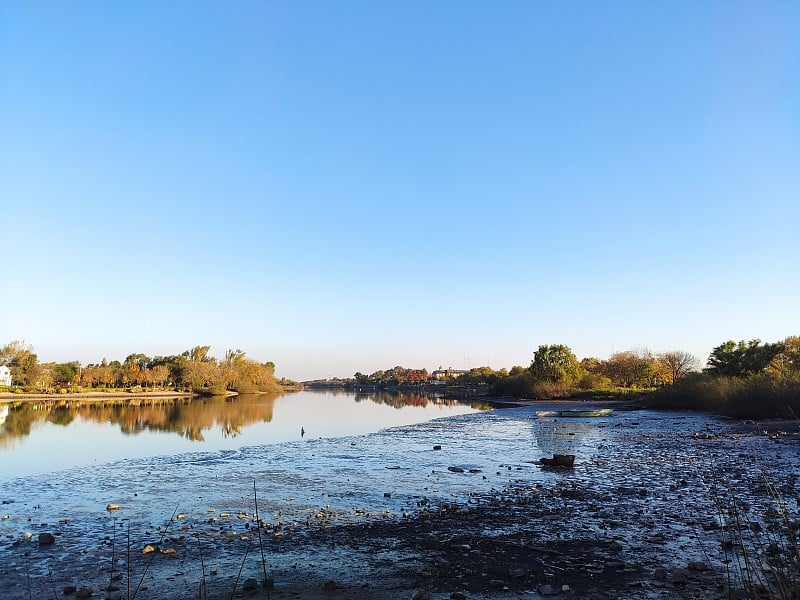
[{"x1": 339, "y1": 336, "x2": 800, "y2": 418}]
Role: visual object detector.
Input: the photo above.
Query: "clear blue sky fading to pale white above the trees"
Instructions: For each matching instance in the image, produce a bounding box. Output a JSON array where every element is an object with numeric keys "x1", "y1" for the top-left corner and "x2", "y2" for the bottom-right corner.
[{"x1": 0, "y1": 0, "x2": 800, "y2": 379}]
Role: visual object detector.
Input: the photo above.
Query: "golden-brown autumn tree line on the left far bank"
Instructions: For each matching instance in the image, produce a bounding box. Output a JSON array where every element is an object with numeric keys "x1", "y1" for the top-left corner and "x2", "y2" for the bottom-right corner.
[{"x1": 0, "y1": 341, "x2": 294, "y2": 394}]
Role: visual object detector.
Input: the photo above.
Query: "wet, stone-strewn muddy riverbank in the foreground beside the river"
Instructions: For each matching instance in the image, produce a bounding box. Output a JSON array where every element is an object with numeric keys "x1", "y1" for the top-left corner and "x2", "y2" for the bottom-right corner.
[{"x1": 0, "y1": 407, "x2": 800, "y2": 599}]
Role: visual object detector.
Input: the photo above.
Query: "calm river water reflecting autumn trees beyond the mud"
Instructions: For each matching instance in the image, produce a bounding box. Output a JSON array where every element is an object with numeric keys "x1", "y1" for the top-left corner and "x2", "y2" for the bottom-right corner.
[{"x1": 0, "y1": 391, "x2": 486, "y2": 480}]
